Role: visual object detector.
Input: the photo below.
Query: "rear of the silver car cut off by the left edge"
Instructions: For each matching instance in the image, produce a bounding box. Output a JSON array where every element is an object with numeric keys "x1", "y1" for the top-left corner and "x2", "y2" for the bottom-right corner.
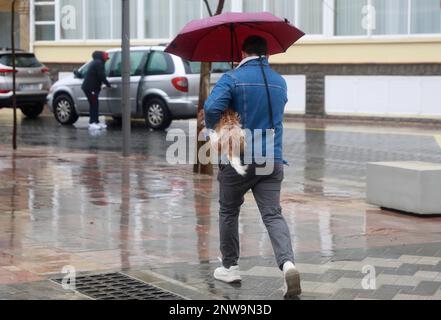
[{"x1": 0, "y1": 50, "x2": 51, "y2": 118}]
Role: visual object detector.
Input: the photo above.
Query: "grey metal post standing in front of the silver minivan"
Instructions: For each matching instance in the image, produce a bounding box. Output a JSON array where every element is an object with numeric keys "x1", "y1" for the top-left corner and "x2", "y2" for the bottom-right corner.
[{"x1": 121, "y1": 0, "x2": 131, "y2": 157}]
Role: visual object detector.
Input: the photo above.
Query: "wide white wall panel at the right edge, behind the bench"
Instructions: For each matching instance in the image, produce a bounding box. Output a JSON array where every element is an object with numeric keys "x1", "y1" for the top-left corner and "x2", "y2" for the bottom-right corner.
[{"x1": 325, "y1": 76, "x2": 441, "y2": 116}]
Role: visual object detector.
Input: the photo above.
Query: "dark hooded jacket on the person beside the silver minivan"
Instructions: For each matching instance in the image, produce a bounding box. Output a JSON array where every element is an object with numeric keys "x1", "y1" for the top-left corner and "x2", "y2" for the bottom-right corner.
[{"x1": 81, "y1": 51, "x2": 110, "y2": 93}]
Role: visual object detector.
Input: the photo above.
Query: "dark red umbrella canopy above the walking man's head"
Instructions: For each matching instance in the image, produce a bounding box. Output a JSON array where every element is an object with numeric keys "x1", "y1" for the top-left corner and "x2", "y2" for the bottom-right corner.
[{"x1": 165, "y1": 12, "x2": 305, "y2": 62}]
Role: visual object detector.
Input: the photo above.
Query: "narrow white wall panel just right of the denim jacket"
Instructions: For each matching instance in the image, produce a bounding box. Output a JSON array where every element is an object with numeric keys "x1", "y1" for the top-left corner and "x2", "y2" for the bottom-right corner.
[{"x1": 283, "y1": 75, "x2": 306, "y2": 113}]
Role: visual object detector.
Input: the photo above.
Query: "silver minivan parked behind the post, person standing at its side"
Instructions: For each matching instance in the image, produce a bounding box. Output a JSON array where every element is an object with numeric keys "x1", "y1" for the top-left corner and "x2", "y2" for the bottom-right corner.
[{"x1": 48, "y1": 46, "x2": 230, "y2": 130}]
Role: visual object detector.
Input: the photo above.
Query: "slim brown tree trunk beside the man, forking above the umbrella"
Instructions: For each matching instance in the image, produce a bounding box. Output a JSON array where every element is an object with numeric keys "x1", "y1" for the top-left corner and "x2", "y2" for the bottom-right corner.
[{"x1": 193, "y1": 0, "x2": 225, "y2": 175}]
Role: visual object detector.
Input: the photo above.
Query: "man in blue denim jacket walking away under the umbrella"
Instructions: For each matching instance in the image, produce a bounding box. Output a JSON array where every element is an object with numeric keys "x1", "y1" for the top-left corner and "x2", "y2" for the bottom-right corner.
[{"x1": 204, "y1": 36, "x2": 301, "y2": 297}]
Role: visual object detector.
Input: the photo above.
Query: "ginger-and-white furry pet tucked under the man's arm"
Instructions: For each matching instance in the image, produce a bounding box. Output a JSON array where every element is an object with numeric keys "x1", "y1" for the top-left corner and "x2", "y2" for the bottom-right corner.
[{"x1": 210, "y1": 109, "x2": 248, "y2": 176}]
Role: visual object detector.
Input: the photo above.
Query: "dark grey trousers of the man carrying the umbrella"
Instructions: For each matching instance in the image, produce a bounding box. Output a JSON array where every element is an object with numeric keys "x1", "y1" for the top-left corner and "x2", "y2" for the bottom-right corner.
[{"x1": 218, "y1": 163, "x2": 294, "y2": 269}]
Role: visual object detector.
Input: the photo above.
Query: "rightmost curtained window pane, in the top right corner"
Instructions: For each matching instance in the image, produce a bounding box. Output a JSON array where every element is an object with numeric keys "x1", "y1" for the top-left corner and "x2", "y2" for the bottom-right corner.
[{"x1": 411, "y1": 0, "x2": 441, "y2": 34}]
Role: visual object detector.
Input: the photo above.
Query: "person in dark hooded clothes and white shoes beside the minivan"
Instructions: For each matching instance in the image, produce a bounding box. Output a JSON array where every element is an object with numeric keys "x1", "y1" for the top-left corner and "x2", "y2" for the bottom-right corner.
[{"x1": 81, "y1": 51, "x2": 111, "y2": 130}]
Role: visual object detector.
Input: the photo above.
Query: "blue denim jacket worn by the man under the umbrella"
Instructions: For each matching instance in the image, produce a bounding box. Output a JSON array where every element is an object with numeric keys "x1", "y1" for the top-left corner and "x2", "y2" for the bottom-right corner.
[{"x1": 204, "y1": 59, "x2": 288, "y2": 163}]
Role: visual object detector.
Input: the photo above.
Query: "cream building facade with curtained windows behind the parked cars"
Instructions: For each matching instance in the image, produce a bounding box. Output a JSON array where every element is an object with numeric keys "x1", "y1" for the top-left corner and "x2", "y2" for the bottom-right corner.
[{"x1": 0, "y1": 0, "x2": 441, "y2": 117}]
